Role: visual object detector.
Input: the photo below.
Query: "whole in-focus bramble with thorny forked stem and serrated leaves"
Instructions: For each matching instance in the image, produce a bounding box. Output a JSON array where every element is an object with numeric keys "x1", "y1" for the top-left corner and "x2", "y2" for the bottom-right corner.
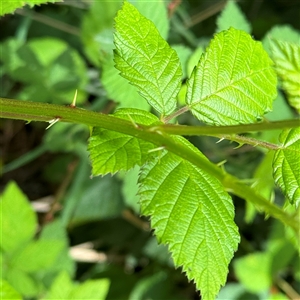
[{"x1": 0, "y1": 1, "x2": 300, "y2": 300}]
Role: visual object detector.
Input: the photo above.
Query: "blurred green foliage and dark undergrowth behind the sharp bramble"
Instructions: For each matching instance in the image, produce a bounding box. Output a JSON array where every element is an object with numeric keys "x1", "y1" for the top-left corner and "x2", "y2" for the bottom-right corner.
[{"x1": 0, "y1": 0, "x2": 300, "y2": 300}]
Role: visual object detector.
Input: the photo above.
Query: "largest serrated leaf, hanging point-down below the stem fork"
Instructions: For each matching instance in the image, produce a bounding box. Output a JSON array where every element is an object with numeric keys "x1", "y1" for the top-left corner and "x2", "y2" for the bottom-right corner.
[{"x1": 139, "y1": 139, "x2": 239, "y2": 299}]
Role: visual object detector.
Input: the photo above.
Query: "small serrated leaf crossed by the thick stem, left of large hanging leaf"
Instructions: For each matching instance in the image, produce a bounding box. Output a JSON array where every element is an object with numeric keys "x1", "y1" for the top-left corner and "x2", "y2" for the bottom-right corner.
[{"x1": 88, "y1": 109, "x2": 158, "y2": 175}]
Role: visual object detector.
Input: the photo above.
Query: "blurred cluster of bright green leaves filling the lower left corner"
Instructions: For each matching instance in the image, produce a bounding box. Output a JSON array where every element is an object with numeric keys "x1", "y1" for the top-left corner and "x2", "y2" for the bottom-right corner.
[{"x1": 0, "y1": 182, "x2": 109, "y2": 300}]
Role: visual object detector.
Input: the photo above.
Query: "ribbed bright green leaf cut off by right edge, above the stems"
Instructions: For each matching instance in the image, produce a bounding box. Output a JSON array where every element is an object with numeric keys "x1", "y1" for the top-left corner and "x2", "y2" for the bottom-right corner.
[{"x1": 271, "y1": 40, "x2": 300, "y2": 113}]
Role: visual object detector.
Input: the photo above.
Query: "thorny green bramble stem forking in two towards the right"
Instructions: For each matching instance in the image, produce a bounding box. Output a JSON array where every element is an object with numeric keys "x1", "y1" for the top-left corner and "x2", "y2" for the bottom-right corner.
[{"x1": 0, "y1": 98, "x2": 299, "y2": 230}]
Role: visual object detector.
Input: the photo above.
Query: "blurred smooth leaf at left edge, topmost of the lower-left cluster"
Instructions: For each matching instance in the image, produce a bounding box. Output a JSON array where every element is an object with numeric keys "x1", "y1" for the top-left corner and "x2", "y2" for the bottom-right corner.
[{"x1": 0, "y1": 182, "x2": 37, "y2": 253}]
